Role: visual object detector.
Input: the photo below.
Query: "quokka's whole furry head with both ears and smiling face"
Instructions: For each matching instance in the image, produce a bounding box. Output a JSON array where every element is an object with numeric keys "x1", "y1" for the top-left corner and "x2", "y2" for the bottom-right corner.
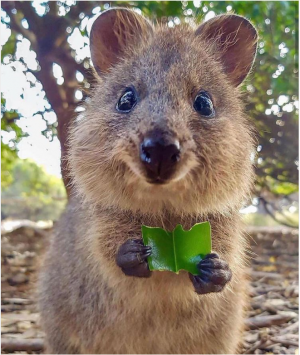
[{"x1": 70, "y1": 8, "x2": 257, "y2": 213}]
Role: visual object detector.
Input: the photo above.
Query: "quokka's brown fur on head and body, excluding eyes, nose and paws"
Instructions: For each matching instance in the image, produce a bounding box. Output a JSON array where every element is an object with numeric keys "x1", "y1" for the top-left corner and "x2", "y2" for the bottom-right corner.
[{"x1": 40, "y1": 7, "x2": 256, "y2": 354}]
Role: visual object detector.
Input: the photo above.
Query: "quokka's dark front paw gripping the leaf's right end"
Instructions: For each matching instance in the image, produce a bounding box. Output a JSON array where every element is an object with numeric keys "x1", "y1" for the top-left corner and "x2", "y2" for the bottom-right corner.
[{"x1": 189, "y1": 253, "x2": 232, "y2": 295}]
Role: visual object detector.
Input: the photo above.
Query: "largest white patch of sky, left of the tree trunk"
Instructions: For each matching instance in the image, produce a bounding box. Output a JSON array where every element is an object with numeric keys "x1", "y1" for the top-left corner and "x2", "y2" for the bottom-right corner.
[{"x1": 1, "y1": 56, "x2": 61, "y2": 176}]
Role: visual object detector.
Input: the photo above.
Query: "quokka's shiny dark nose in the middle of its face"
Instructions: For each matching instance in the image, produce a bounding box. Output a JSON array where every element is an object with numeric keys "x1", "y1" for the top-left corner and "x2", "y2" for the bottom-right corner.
[{"x1": 140, "y1": 135, "x2": 180, "y2": 183}]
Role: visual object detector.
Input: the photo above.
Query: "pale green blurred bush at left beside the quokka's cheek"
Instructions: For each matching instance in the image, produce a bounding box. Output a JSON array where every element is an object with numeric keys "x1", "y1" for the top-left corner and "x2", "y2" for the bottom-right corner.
[{"x1": 1, "y1": 158, "x2": 66, "y2": 220}]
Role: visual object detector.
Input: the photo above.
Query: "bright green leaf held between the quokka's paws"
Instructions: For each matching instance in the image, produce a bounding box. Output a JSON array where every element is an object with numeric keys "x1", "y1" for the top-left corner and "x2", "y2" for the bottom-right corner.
[{"x1": 142, "y1": 222, "x2": 211, "y2": 275}]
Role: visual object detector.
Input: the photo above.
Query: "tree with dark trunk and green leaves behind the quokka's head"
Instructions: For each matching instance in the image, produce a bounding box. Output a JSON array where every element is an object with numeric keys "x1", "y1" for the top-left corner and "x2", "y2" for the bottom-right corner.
[{"x1": 1, "y1": 0, "x2": 298, "y2": 202}]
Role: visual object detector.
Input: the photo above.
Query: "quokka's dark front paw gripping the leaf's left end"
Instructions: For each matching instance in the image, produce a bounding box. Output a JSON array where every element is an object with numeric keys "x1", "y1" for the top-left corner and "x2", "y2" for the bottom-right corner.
[{"x1": 116, "y1": 239, "x2": 152, "y2": 277}]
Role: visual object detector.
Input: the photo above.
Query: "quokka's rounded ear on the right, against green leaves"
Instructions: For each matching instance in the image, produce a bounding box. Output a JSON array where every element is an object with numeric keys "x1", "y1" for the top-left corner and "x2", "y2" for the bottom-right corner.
[{"x1": 195, "y1": 14, "x2": 258, "y2": 86}]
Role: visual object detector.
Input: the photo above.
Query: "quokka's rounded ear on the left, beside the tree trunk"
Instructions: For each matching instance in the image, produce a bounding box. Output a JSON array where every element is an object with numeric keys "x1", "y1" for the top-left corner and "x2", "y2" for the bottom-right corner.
[{"x1": 90, "y1": 8, "x2": 153, "y2": 75}]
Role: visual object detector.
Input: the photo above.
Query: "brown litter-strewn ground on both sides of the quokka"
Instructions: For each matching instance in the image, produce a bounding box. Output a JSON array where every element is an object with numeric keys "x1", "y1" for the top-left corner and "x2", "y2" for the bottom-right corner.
[{"x1": 1, "y1": 226, "x2": 299, "y2": 354}]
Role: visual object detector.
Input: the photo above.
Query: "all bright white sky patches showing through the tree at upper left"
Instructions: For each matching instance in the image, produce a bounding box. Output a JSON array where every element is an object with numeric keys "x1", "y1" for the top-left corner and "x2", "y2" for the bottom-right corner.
[{"x1": 0, "y1": 1, "x2": 100, "y2": 177}]
